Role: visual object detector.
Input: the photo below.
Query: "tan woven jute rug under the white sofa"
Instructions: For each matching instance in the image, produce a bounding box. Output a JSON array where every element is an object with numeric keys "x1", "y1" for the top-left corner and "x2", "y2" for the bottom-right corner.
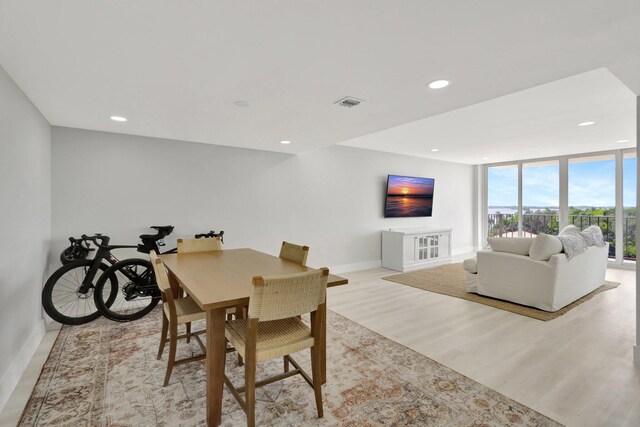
[{"x1": 383, "y1": 263, "x2": 620, "y2": 321}]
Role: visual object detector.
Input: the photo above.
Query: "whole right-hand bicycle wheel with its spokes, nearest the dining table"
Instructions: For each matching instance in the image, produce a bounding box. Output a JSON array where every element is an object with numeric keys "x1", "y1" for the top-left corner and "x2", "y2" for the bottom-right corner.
[{"x1": 94, "y1": 258, "x2": 161, "y2": 322}]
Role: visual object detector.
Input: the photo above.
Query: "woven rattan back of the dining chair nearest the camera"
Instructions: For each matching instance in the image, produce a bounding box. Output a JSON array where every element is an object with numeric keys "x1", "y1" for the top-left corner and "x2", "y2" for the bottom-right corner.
[{"x1": 249, "y1": 269, "x2": 329, "y2": 321}]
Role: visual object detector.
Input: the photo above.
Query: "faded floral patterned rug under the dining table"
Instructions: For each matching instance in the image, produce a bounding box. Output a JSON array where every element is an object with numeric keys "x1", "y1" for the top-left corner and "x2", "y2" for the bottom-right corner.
[{"x1": 18, "y1": 309, "x2": 560, "y2": 427}]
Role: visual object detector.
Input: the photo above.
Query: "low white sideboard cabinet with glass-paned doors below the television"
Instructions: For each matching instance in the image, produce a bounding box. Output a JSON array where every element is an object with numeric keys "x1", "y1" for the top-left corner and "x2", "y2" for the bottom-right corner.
[{"x1": 382, "y1": 228, "x2": 451, "y2": 271}]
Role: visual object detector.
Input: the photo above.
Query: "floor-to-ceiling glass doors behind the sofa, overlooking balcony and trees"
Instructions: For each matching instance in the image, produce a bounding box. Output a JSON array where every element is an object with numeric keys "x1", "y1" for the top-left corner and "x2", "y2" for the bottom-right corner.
[{"x1": 484, "y1": 149, "x2": 637, "y2": 264}]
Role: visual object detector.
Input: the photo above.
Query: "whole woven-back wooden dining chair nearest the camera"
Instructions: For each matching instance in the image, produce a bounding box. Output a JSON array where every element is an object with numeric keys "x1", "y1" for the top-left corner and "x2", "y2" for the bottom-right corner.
[{"x1": 224, "y1": 268, "x2": 329, "y2": 427}]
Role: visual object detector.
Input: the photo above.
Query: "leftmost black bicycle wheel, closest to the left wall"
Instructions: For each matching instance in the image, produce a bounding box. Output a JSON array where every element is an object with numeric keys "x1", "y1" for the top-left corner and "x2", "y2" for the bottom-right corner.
[{"x1": 42, "y1": 259, "x2": 118, "y2": 325}]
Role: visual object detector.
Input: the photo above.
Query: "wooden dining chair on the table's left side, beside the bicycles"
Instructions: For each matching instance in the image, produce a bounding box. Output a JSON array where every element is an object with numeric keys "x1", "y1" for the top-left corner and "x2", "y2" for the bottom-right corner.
[{"x1": 149, "y1": 251, "x2": 206, "y2": 387}]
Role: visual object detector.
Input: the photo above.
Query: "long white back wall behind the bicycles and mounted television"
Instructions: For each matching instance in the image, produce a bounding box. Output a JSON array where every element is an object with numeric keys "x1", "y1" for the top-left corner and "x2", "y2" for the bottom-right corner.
[{"x1": 52, "y1": 127, "x2": 475, "y2": 272}]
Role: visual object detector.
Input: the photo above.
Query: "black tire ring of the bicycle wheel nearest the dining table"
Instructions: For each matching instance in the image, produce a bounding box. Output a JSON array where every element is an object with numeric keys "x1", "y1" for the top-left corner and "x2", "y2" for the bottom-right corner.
[{"x1": 94, "y1": 258, "x2": 161, "y2": 322}]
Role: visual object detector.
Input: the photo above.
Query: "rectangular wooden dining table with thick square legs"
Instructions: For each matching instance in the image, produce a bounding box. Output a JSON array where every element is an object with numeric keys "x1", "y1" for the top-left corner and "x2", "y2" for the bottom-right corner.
[{"x1": 160, "y1": 248, "x2": 348, "y2": 426}]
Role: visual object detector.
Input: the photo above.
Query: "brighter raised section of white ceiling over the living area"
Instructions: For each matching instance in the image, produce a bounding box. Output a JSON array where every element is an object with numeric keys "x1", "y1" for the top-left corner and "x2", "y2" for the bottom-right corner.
[{"x1": 342, "y1": 68, "x2": 636, "y2": 164}]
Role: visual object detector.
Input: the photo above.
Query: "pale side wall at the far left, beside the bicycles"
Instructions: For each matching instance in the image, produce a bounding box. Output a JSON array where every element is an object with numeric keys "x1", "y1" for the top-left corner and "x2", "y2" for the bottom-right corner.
[{"x1": 0, "y1": 67, "x2": 51, "y2": 410}]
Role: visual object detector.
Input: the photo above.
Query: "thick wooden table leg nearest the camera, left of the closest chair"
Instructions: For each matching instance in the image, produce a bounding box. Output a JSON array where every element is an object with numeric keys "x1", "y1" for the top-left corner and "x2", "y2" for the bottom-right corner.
[{"x1": 206, "y1": 308, "x2": 227, "y2": 427}]
